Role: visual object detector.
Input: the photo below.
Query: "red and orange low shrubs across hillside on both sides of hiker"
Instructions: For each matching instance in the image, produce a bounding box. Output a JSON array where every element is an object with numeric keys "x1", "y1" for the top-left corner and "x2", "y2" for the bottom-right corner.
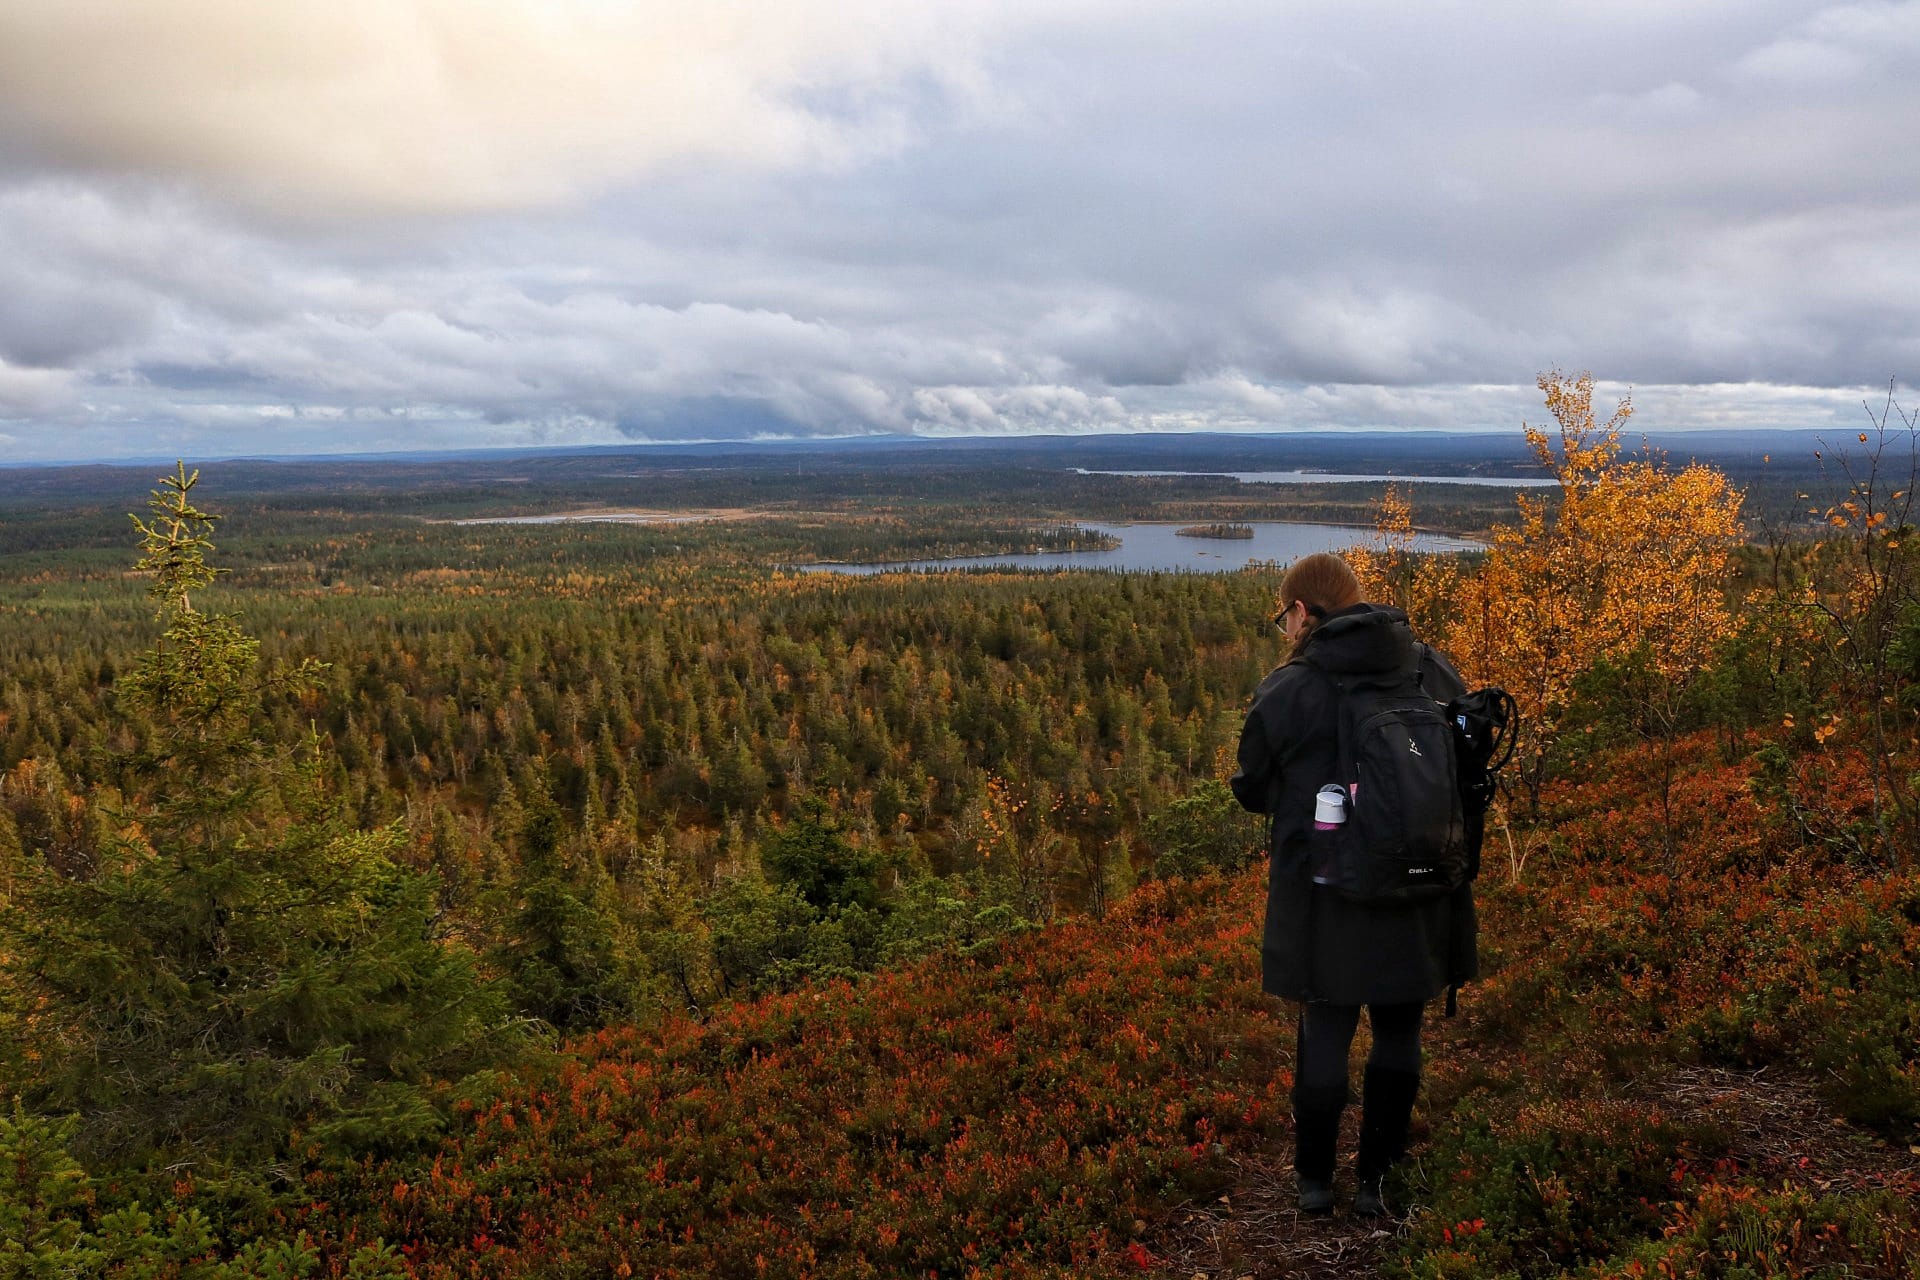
[{"x1": 284, "y1": 737, "x2": 1920, "y2": 1276}]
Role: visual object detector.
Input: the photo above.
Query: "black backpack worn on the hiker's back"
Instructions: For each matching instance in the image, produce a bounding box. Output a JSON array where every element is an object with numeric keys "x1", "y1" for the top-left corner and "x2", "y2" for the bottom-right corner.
[{"x1": 1309, "y1": 645, "x2": 1513, "y2": 906}]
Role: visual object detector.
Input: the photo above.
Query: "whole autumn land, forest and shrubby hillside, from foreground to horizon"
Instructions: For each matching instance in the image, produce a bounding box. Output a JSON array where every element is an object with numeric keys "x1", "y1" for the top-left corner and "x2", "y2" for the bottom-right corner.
[{"x1": 0, "y1": 372, "x2": 1920, "y2": 1280}]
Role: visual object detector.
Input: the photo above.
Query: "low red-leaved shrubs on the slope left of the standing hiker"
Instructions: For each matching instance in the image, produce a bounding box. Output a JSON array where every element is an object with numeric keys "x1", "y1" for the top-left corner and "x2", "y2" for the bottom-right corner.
[{"x1": 301, "y1": 875, "x2": 1290, "y2": 1278}]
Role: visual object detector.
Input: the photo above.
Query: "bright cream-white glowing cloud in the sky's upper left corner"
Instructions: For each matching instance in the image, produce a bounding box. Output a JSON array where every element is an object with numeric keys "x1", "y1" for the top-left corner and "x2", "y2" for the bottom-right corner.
[{"x1": 0, "y1": 0, "x2": 1010, "y2": 217}]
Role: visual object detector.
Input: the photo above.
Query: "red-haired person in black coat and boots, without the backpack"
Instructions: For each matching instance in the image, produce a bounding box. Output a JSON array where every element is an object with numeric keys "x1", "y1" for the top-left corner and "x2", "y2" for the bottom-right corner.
[{"x1": 1233, "y1": 553, "x2": 1478, "y2": 1215}]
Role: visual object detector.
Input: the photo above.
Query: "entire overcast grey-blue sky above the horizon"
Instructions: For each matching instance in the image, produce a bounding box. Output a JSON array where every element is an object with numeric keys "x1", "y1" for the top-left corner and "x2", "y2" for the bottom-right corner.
[{"x1": 0, "y1": 0, "x2": 1920, "y2": 462}]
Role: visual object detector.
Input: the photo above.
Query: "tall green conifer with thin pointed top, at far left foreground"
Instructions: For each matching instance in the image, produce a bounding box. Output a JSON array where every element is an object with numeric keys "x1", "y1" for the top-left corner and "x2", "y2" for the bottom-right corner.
[{"x1": 0, "y1": 466, "x2": 501, "y2": 1163}]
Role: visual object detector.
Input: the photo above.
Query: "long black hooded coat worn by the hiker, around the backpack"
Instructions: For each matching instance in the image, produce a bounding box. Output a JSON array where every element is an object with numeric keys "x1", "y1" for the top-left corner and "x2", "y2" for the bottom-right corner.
[{"x1": 1233, "y1": 604, "x2": 1478, "y2": 1004}]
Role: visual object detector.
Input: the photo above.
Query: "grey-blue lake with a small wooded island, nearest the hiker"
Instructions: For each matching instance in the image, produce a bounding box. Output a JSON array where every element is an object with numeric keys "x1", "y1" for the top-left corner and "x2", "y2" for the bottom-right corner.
[{"x1": 793, "y1": 520, "x2": 1482, "y2": 574}]
